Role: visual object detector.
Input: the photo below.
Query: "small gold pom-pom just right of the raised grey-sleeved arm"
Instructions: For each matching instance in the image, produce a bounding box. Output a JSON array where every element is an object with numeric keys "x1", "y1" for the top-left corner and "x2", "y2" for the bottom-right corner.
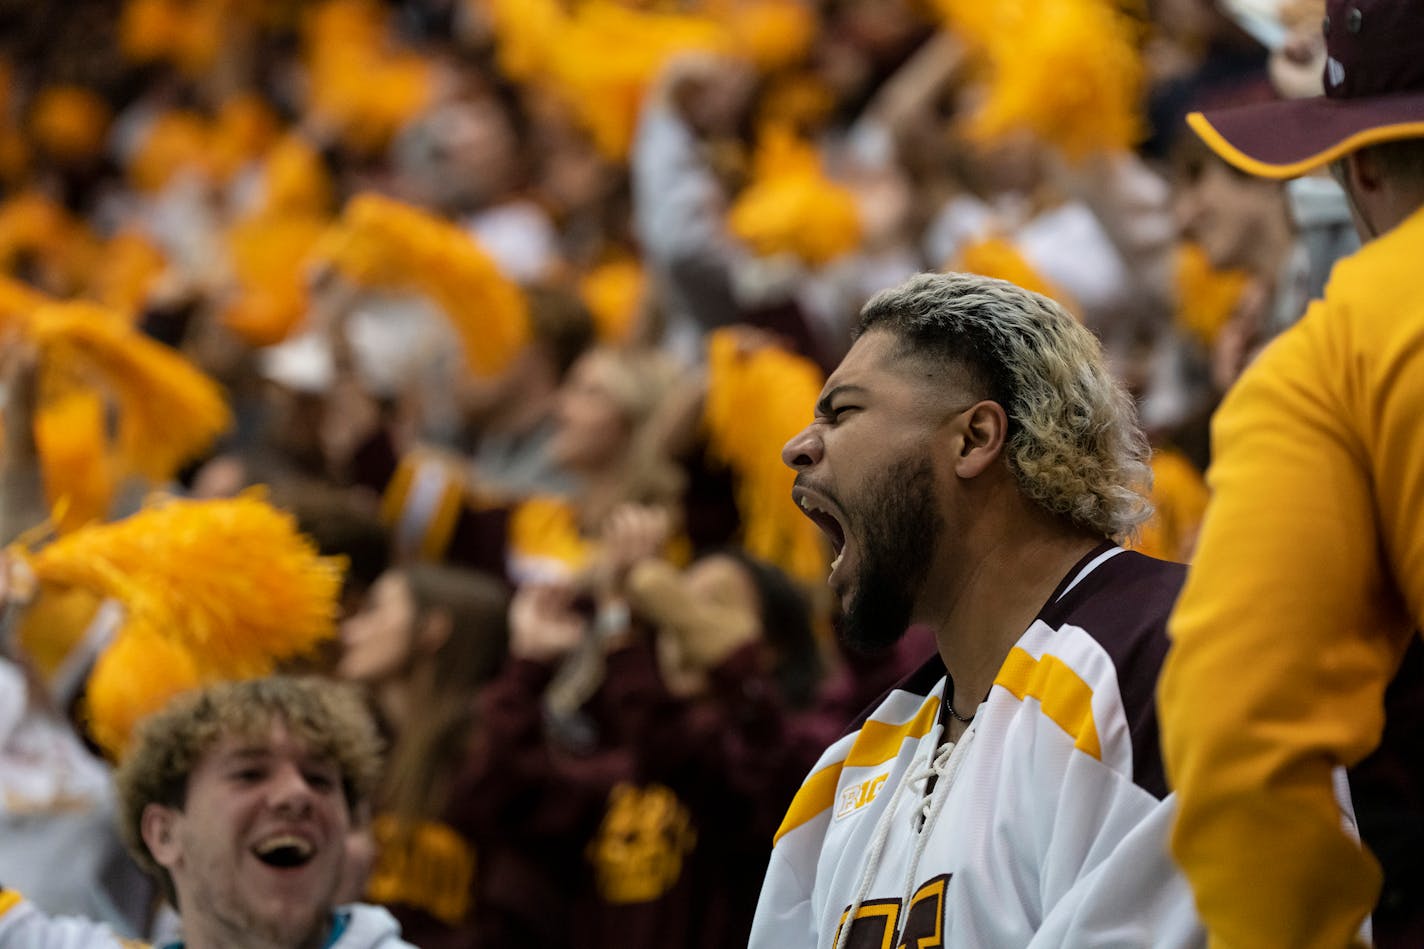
[{"x1": 728, "y1": 127, "x2": 860, "y2": 266}]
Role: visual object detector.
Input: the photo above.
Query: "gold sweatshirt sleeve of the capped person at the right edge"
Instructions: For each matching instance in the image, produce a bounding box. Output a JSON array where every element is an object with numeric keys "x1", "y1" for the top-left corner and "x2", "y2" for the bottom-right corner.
[{"x1": 1159, "y1": 200, "x2": 1424, "y2": 948}]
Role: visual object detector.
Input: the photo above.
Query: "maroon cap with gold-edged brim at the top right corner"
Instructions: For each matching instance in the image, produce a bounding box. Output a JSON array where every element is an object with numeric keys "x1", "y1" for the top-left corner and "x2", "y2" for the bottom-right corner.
[{"x1": 1186, "y1": 0, "x2": 1424, "y2": 178}]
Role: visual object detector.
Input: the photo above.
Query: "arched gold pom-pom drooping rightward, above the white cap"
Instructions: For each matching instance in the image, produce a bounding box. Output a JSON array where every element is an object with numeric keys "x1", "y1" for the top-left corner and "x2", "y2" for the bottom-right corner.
[{"x1": 313, "y1": 194, "x2": 530, "y2": 376}]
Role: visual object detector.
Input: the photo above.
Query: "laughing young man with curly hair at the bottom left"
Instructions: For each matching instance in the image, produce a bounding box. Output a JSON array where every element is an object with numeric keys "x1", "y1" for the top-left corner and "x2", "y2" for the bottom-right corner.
[{"x1": 0, "y1": 677, "x2": 407, "y2": 949}]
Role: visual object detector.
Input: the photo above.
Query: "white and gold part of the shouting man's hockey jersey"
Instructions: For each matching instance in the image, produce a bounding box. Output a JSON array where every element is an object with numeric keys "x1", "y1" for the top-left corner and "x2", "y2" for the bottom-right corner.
[{"x1": 750, "y1": 547, "x2": 1205, "y2": 949}]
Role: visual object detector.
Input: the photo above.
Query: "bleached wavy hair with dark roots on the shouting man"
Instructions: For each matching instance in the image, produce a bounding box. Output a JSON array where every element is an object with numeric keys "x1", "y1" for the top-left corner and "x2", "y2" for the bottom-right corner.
[{"x1": 856, "y1": 274, "x2": 1152, "y2": 540}]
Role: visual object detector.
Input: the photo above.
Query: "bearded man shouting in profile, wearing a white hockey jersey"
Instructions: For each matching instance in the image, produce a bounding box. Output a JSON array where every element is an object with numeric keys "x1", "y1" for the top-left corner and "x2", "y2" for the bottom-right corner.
[{"x1": 752, "y1": 274, "x2": 1200, "y2": 949}]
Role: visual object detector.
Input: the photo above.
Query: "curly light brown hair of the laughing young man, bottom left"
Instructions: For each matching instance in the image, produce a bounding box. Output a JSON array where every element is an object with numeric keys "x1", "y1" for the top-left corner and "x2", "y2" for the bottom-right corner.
[{"x1": 114, "y1": 675, "x2": 382, "y2": 906}]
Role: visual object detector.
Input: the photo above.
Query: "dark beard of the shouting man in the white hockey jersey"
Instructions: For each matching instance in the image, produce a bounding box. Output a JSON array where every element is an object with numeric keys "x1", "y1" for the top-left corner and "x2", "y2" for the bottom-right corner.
[{"x1": 842, "y1": 455, "x2": 944, "y2": 651}]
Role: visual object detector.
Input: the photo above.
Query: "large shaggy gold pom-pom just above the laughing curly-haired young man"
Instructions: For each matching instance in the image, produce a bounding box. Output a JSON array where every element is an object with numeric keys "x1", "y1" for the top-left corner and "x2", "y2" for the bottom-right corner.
[{"x1": 10, "y1": 493, "x2": 342, "y2": 757}]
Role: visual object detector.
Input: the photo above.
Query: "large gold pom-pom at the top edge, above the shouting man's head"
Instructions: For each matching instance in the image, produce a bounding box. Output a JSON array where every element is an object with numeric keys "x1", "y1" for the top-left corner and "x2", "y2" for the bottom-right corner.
[{"x1": 937, "y1": 0, "x2": 1143, "y2": 160}]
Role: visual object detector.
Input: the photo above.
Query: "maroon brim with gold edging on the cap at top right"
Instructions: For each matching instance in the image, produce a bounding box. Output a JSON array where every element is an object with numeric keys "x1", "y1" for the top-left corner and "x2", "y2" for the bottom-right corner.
[{"x1": 1186, "y1": 91, "x2": 1424, "y2": 178}]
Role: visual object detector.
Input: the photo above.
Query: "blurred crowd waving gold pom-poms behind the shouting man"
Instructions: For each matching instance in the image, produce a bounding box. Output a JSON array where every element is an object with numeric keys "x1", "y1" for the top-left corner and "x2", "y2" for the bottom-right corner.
[{"x1": 0, "y1": 0, "x2": 1356, "y2": 949}]
